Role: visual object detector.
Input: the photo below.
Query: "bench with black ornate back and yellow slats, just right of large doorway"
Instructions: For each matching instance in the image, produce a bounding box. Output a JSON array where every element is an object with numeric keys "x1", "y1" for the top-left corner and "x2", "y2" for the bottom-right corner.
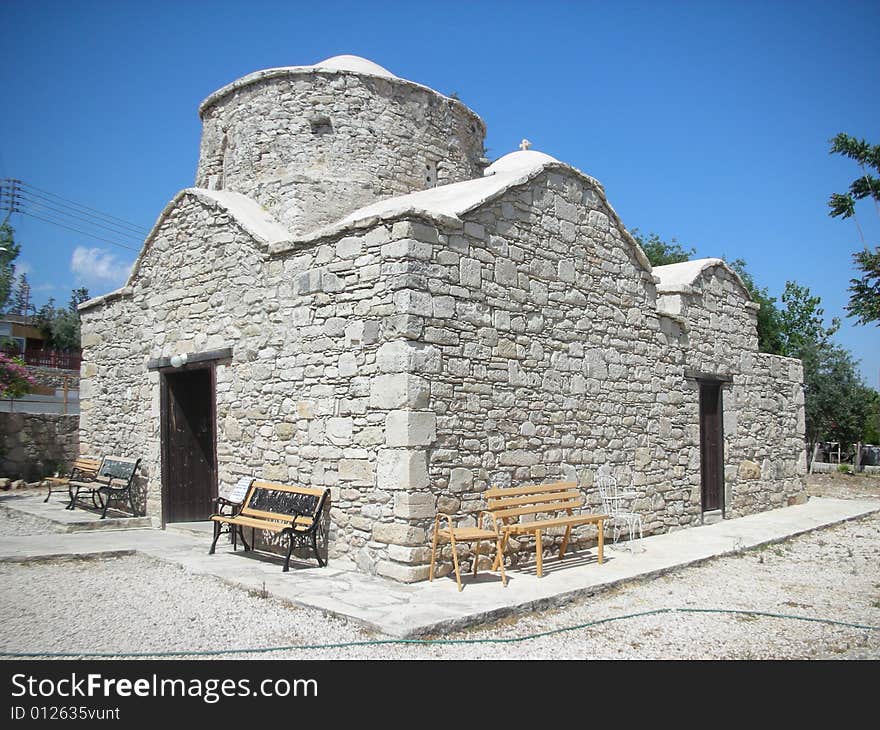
[{"x1": 208, "y1": 480, "x2": 330, "y2": 572}]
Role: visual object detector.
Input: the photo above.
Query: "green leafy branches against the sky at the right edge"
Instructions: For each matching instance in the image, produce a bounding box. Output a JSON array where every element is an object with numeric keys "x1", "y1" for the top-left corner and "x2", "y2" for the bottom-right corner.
[{"x1": 828, "y1": 132, "x2": 880, "y2": 325}]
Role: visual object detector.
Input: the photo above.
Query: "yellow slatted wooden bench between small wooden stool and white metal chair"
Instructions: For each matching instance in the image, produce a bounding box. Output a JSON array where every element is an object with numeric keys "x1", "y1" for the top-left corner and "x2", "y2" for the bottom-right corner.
[{"x1": 484, "y1": 482, "x2": 608, "y2": 578}]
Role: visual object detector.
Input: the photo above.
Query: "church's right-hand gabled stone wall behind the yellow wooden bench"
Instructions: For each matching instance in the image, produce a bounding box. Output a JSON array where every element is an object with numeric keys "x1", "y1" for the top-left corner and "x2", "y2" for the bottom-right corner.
[{"x1": 348, "y1": 173, "x2": 699, "y2": 580}]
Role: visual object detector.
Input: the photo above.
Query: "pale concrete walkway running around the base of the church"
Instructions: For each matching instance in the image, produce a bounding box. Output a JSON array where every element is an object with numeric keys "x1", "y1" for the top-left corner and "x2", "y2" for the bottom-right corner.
[{"x1": 0, "y1": 494, "x2": 880, "y2": 637}]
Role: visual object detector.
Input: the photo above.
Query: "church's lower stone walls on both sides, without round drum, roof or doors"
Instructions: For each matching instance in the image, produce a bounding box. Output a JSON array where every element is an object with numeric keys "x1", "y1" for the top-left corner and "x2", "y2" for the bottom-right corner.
[{"x1": 82, "y1": 164, "x2": 803, "y2": 581}]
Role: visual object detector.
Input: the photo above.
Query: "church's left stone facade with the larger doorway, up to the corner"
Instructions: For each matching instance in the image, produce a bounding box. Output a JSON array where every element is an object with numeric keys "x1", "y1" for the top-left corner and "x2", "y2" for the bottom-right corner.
[{"x1": 82, "y1": 191, "x2": 460, "y2": 564}]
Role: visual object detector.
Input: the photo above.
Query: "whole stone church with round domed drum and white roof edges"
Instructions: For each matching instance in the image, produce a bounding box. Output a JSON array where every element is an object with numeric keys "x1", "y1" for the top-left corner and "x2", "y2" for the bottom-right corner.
[{"x1": 80, "y1": 56, "x2": 805, "y2": 582}]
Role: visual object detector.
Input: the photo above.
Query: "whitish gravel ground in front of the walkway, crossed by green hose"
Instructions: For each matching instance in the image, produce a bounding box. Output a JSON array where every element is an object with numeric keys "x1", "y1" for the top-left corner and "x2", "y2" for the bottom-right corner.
[{"x1": 0, "y1": 475, "x2": 880, "y2": 660}]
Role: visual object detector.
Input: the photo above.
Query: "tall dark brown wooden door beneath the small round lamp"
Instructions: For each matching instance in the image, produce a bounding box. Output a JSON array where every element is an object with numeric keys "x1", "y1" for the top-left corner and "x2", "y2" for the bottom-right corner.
[{"x1": 162, "y1": 368, "x2": 217, "y2": 522}]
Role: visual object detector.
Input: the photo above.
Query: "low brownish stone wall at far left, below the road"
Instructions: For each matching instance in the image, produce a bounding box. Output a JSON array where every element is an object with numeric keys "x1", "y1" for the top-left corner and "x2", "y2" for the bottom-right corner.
[{"x1": 0, "y1": 413, "x2": 79, "y2": 481}]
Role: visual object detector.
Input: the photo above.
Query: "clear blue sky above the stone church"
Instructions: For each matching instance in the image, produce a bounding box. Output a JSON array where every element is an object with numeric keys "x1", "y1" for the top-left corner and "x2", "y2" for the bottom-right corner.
[{"x1": 0, "y1": 0, "x2": 880, "y2": 387}]
